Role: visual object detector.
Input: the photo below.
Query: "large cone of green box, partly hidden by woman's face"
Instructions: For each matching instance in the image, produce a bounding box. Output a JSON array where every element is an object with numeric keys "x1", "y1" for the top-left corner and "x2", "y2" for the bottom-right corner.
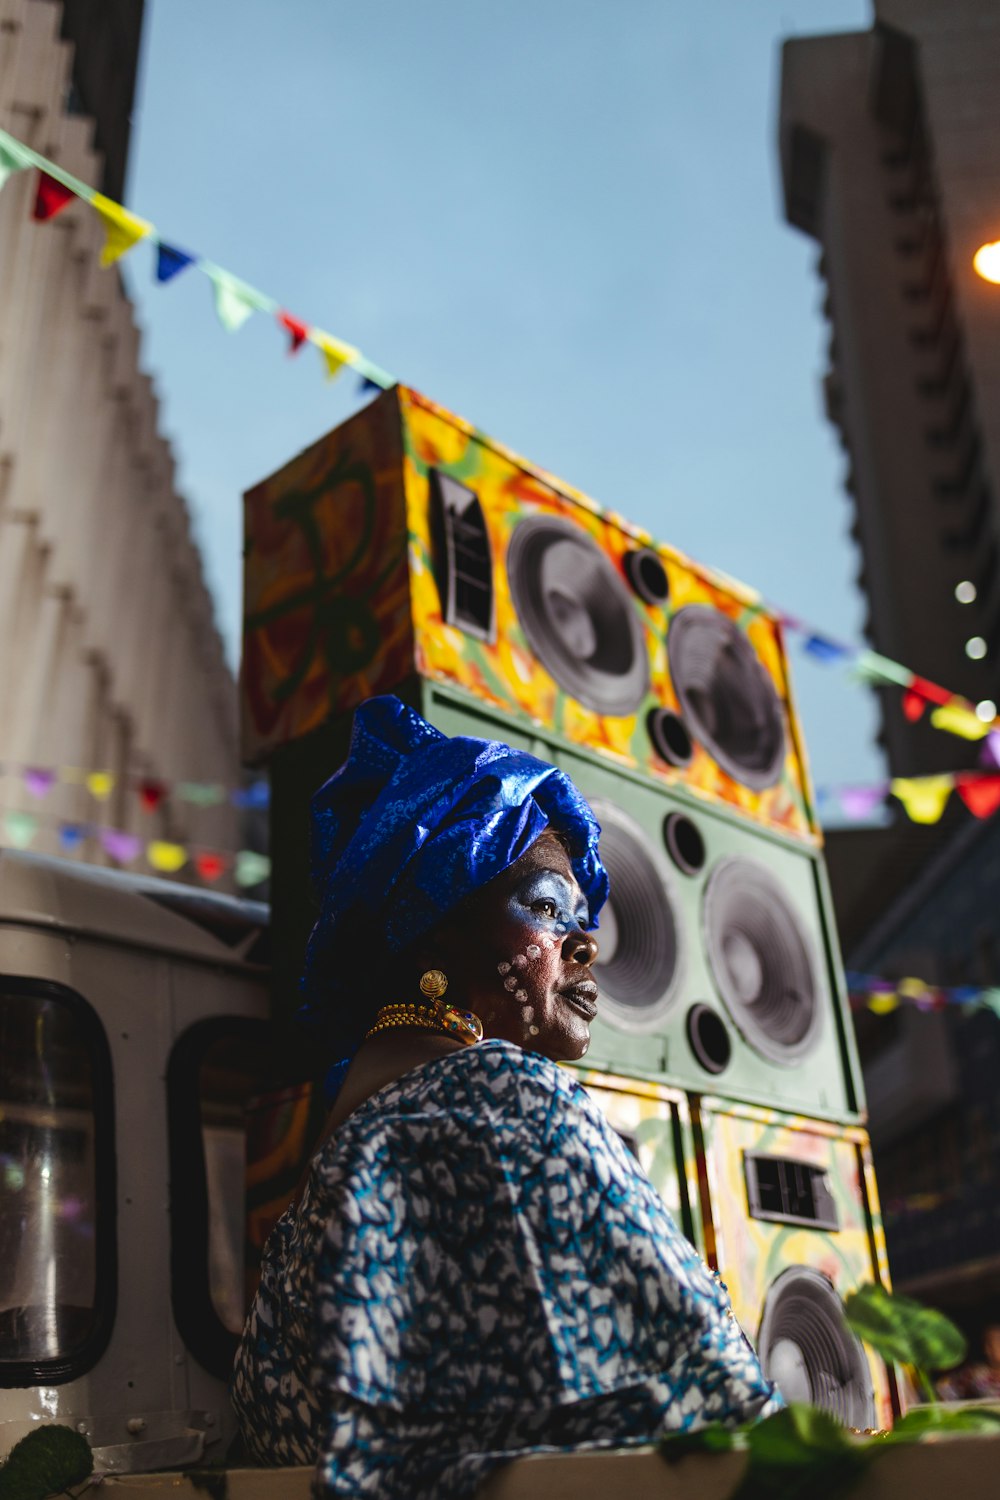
[{"x1": 592, "y1": 800, "x2": 682, "y2": 1031}]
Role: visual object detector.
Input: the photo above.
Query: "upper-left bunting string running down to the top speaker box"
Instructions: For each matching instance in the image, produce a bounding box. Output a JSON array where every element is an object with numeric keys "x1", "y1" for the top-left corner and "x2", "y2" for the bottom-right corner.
[{"x1": 0, "y1": 131, "x2": 396, "y2": 390}]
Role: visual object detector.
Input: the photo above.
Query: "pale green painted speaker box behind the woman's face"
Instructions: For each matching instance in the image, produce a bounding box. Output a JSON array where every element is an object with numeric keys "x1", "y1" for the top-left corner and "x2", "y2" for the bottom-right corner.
[{"x1": 421, "y1": 684, "x2": 864, "y2": 1121}]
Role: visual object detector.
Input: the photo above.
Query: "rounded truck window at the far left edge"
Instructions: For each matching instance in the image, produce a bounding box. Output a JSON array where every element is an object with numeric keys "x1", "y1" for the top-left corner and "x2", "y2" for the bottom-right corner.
[{"x1": 0, "y1": 975, "x2": 114, "y2": 1386}]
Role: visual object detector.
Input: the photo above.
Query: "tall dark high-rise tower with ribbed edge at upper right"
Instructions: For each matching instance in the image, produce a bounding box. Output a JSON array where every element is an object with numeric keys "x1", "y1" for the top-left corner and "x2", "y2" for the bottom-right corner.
[{"x1": 780, "y1": 0, "x2": 1000, "y2": 776}]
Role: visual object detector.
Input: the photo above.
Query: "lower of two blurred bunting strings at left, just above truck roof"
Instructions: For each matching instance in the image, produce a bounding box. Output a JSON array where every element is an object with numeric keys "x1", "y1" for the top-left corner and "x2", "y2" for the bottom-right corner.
[{"x1": 0, "y1": 809, "x2": 271, "y2": 888}]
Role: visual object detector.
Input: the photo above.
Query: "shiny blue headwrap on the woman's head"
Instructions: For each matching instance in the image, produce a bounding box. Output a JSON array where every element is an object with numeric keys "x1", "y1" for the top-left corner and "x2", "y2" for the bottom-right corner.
[{"x1": 300, "y1": 696, "x2": 607, "y2": 1046}]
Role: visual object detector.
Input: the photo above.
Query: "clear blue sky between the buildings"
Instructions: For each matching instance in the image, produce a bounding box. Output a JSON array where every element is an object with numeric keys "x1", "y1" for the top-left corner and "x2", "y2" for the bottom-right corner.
[{"x1": 124, "y1": 0, "x2": 882, "y2": 785}]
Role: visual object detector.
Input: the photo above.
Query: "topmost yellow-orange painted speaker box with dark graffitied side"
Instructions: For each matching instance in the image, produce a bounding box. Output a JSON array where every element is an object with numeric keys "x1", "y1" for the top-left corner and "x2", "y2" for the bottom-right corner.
[{"x1": 241, "y1": 387, "x2": 819, "y2": 843}]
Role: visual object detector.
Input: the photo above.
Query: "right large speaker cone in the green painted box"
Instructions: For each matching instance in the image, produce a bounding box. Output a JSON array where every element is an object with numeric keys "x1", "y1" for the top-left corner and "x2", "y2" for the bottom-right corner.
[{"x1": 703, "y1": 855, "x2": 822, "y2": 1064}]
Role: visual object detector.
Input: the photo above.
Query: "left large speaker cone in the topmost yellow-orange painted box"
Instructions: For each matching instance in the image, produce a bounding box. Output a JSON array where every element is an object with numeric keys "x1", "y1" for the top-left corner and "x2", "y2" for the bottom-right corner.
[{"x1": 507, "y1": 516, "x2": 649, "y2": 716}]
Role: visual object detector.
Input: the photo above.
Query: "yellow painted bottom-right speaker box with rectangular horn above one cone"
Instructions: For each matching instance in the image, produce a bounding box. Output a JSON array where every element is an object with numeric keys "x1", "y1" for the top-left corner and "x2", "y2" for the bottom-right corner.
[{"x1": 693, "y1": 1100, "x2": 898, "y2": 1428}]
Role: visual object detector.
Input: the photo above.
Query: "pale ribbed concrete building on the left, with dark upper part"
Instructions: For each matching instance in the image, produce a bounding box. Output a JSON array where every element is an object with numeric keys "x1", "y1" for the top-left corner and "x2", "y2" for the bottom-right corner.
[{"x1": 0, "y1": 0, "x2": 240, "y2": 884}]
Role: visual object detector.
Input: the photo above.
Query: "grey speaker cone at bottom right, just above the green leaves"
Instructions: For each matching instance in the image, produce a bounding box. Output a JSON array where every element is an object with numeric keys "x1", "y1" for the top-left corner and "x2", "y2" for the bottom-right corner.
[{"x1": 757, "y1": 1266, "x2": 876, "y2": 1428}]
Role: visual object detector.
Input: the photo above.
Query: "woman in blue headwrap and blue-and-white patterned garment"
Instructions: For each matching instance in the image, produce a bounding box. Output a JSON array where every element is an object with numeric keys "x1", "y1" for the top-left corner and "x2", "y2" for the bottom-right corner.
[{"x1": 234, "y1": 698, "x2": 777, "y2": 1500}]
